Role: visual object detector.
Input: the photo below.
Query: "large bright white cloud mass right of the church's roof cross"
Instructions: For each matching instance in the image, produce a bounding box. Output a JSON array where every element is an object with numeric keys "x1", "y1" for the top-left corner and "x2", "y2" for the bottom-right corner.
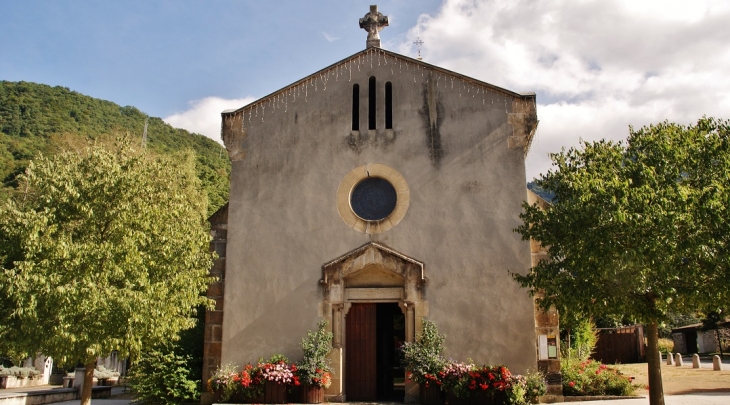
[{"x1": 399, "y1": 0, "x2": 730, "y2": 179}]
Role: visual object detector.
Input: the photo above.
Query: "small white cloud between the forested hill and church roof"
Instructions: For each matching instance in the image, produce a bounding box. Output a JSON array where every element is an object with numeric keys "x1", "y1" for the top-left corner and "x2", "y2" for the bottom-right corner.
[{"x1": 162, "y1": 97, "x2": 256, "y2": 143}]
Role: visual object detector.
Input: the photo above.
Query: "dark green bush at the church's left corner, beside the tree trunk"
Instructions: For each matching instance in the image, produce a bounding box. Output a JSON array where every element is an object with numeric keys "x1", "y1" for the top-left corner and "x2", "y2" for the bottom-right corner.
[{"x1": 127, "y1": 347, "x2": 200, "y2": 405}]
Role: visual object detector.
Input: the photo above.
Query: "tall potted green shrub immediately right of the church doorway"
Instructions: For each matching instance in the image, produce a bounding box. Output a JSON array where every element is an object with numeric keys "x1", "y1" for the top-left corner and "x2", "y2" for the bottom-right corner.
[{"x1": 401, "y1": 319, "x2": 447, "y2": 405}]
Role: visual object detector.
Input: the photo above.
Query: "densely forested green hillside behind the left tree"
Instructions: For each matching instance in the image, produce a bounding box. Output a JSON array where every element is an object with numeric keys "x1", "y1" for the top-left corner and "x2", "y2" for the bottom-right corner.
[{"x1": 0, "y1": 81, "x2": 231, "y2": 213}]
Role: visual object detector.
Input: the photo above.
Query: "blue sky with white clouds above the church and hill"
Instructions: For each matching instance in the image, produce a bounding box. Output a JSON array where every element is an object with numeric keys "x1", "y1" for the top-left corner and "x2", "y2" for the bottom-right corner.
[{"x1": 0, "y1": 0, "x2": 730, "y2": 180}]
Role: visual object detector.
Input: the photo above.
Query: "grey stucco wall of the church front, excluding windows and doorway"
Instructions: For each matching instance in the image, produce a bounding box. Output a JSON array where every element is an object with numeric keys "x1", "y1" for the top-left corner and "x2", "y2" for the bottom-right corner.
[{"x1": 222, "y1": 51, "x2": 536, "y2": 372}]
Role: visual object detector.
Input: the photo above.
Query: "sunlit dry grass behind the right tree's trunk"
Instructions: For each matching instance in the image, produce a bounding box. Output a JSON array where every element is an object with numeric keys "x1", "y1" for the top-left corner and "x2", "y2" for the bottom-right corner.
[{"x1": 616, "y1": 363, "x2": 730, "y2": 395}]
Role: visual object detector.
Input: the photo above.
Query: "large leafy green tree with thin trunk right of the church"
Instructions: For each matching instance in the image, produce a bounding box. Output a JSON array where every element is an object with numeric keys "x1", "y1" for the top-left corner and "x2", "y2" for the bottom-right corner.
[{"x1": 514, "y1": 118, "x2": 730, "y2": 405}]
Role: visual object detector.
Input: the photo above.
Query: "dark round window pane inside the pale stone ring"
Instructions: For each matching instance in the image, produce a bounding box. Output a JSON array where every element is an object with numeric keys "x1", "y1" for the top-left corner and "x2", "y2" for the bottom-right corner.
[{"x1": 350, "y1": 177, "x2": 398, "y2": 221}]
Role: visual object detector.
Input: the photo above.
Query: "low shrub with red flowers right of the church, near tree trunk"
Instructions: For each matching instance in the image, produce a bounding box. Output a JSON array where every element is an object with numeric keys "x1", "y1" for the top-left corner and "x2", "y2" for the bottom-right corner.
[{"x1": 560, "y1": 360, "x2": 635, "y2": 396}]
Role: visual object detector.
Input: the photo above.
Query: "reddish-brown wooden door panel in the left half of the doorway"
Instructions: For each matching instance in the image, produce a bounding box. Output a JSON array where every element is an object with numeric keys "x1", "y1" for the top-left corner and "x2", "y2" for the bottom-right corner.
[{"x1": 345, "y1": 304, "x2": 378, "y2": 401}]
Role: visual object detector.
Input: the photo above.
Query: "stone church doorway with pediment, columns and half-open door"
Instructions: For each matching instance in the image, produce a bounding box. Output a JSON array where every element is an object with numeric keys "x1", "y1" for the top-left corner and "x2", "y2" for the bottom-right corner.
[{"x1": 321, "y1": 242, "x2": 428, "y2": 402}]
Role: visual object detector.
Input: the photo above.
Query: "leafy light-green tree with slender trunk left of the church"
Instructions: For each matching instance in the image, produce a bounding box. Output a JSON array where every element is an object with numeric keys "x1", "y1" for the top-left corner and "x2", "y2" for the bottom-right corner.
[{"x1": 0, "y1": 141, "x2": 212, "y2": 405}]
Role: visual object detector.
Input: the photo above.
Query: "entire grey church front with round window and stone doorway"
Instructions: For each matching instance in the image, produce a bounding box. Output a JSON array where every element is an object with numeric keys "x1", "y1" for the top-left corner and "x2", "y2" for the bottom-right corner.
[{"x1": 204, "y1": 7, "x2": 557, "y2": 402}]
